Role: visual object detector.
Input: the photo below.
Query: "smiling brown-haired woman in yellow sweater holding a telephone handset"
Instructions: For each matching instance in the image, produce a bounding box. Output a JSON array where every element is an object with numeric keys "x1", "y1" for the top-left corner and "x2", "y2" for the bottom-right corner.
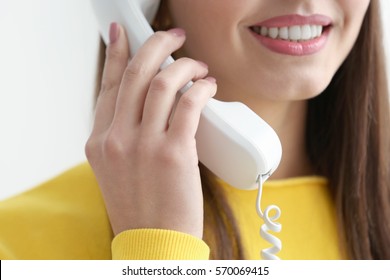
[{"x1": 0, "y1": 0, "x2": 390, "y2": 259}]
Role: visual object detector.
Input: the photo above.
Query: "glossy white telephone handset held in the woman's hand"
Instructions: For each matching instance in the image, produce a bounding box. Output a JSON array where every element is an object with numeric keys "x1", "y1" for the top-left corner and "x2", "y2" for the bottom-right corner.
[{"x1": 92, "y1": 0, "x2": 282, "y2": 189}]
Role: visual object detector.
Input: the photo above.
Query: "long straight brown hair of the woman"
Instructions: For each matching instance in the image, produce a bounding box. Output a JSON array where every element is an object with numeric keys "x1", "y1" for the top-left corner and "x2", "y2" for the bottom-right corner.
[{"x1": 98, "y1": 0, "x2": 390, "y2": 259}]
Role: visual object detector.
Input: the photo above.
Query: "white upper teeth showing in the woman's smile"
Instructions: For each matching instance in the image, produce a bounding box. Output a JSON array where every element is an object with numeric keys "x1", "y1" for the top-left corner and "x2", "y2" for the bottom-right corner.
[{"x1": 252, "y1": 25, "x2": 322, "y2": 41}]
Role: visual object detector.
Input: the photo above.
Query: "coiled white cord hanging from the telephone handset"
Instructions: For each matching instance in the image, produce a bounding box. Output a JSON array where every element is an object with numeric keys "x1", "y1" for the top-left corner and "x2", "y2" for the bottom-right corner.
[{"x1": 256, "y1": 174, "x2": 282, "y2": 260}]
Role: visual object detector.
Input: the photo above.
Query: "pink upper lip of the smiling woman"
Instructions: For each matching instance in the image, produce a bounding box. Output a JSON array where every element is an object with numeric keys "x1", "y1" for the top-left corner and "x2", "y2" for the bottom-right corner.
[{"x1": 253, "y1": 14, "x2": 332, "y2": 28}]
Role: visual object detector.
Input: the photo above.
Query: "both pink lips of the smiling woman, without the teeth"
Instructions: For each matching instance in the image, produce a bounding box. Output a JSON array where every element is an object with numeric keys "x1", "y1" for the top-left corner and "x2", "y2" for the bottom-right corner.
[{"x1": 249, "y1": 14, "x2": 332, "y2": 56}]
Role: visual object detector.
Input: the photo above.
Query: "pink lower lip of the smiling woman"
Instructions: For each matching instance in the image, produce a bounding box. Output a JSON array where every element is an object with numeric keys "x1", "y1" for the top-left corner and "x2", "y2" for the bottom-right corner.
[{"x1": 250, "y1": 28, "x2": 330, "y2": 56}]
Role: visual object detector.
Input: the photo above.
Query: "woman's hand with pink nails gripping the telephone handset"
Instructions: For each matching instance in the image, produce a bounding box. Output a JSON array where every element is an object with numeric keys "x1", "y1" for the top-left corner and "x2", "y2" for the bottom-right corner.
[{"x1": 86, "y1": 24, "x2": 216, "y2": 238}]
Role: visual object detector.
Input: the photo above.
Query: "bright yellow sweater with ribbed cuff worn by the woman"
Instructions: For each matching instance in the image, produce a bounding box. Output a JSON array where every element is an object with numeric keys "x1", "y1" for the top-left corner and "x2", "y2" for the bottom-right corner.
[{"x1": 0, "y1": 164, "x2": 344, "y2": 259}]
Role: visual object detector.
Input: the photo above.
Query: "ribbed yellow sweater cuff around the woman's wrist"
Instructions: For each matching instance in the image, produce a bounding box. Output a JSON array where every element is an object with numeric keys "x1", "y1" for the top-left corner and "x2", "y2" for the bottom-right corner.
[{"x1": 112, "y1": 229, "x2": 210, "y2": 260}]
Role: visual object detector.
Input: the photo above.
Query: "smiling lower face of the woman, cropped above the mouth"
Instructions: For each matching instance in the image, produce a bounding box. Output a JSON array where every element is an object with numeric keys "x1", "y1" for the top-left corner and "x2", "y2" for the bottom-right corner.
[{"x1": 167, "y1": 0, "x2": 370, "y2": 105}]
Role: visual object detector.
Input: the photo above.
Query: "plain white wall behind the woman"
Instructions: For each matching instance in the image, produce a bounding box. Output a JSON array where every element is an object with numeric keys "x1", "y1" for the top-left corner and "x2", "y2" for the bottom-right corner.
[{"x1": 0, "y1": 0, "x2": 390, "y2": 199}]
